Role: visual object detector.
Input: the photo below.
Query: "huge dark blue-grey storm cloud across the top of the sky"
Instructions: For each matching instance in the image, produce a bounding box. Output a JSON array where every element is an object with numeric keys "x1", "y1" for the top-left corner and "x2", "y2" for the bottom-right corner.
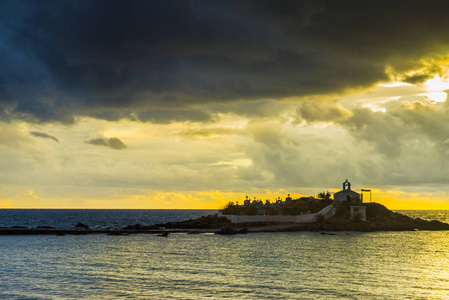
[{"x1": 0, "y1": 0, "x2": 449, "y2": 123}]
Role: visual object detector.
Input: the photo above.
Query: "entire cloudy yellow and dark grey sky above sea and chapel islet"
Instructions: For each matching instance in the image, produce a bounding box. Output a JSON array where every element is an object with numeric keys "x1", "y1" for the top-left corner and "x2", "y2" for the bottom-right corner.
[{"x1": 0, "y1": 0, "x2": 449, "y2": 209}]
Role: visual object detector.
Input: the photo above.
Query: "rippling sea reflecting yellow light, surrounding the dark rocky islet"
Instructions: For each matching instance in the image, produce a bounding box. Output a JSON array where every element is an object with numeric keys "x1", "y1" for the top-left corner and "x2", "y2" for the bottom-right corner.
[{"x1": 0, "y1": 209, "x2": 449, "y2": 299}]
